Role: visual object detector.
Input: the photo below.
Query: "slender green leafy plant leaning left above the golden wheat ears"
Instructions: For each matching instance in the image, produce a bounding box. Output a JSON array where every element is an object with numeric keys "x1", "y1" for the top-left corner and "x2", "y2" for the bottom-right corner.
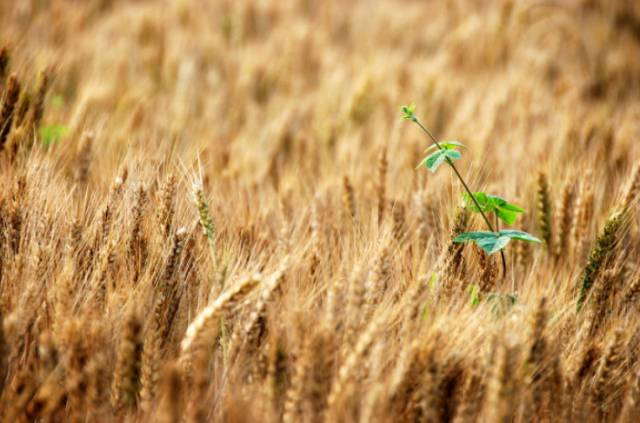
[{"x1": 402, "y1": 104, "x2": 540, "y2": 274}]
